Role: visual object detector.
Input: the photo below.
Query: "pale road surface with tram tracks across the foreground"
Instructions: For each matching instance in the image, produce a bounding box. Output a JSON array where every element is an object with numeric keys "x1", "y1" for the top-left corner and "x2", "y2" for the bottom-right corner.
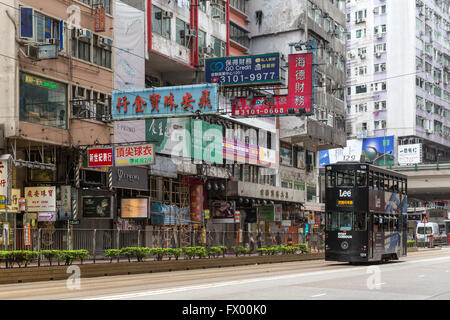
[{"x1": 0, "y1": 247, "x2": 450, "y2": 300}]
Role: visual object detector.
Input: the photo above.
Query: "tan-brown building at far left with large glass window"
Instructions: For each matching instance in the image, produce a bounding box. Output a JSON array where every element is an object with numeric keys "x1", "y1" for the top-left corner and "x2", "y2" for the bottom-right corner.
[{"x1": 0, "y1": 0, "x2": 114, "y2": 227}]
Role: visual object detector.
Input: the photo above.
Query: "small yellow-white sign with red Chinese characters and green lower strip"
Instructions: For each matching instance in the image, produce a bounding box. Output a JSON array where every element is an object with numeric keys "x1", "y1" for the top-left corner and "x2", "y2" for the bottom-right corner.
[{"x1": 114, "y1": 144, "x2": 155, "y2": 167}]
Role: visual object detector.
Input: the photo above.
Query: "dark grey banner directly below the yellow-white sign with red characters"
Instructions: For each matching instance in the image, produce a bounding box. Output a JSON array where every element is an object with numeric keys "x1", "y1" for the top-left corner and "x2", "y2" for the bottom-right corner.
[{"x1": 111, "y1": 167, "x2": 148, "y2": 191}]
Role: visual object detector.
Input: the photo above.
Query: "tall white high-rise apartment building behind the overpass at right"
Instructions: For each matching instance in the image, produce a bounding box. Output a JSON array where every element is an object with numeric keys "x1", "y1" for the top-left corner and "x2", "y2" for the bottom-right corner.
[{"x1": 347, "y1": 0, "x2": 450, "y2": 162}]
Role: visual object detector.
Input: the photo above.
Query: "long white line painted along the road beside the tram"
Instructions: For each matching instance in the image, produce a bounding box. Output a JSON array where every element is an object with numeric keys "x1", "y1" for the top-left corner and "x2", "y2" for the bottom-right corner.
[{"x1": 83, "y1": 256, "x2": 450, "y2": 300}]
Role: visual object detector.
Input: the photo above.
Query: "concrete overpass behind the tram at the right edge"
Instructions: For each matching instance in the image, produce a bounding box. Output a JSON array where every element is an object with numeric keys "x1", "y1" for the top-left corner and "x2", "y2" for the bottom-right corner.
[{"x1": 389, "y1": 163, "x2": 450, "y2": 201}]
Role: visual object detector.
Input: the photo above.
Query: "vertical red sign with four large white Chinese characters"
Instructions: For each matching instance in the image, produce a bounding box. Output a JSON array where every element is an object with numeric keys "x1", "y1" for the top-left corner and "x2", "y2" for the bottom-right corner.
[{"x1": 289, "y1": 53, "x2": 314, "y2": 115}]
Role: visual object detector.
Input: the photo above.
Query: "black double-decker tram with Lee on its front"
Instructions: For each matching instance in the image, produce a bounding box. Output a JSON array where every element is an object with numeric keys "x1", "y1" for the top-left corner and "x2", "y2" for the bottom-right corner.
[{"x1": 325, "y1": 162, "x2": 407, "y2": 263}]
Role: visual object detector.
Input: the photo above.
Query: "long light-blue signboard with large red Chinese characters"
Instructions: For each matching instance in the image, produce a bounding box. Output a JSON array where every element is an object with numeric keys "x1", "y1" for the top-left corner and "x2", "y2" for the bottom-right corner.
[{"x1": 112, "y1": 84, "x2": 219, "y2": 120}]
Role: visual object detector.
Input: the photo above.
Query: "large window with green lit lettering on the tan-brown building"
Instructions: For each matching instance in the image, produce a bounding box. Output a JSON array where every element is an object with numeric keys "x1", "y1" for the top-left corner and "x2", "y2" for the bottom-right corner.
[{"x1": 20, "y1": 73, "x2": 67, "y2": 129}]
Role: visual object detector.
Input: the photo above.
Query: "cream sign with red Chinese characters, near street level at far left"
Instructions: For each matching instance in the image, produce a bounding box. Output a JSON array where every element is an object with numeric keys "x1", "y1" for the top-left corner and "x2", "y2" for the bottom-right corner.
[{"x1": 25, "y1": 187, "x2": 56, "y2": 212}]
